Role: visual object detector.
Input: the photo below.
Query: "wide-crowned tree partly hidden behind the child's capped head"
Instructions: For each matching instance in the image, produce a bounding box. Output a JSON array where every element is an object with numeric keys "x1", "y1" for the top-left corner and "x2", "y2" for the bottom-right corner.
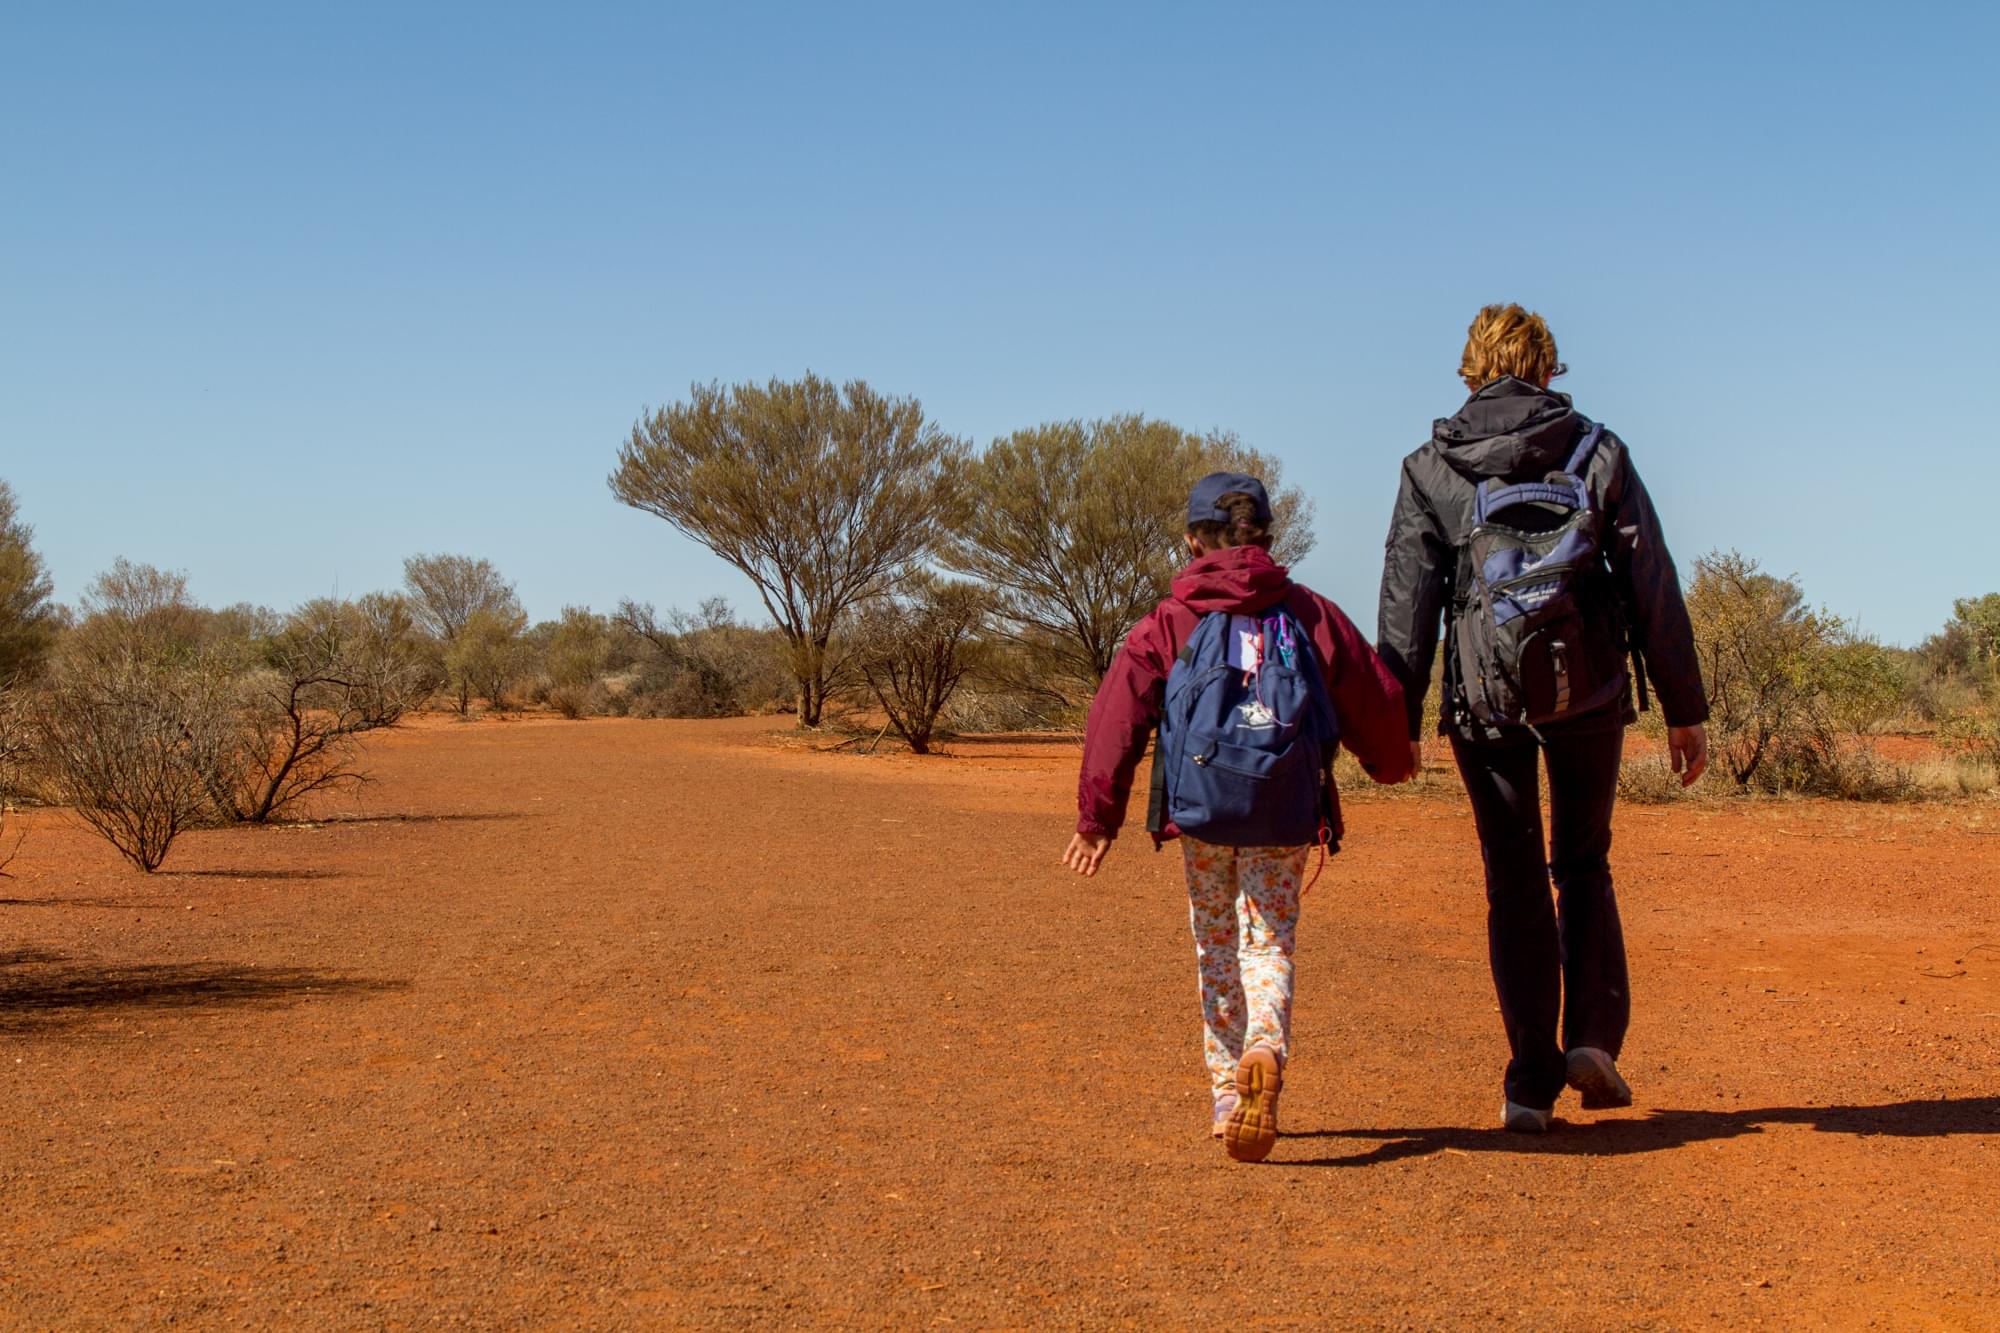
[{"x1": 942, "y1": 414, "x2": 1314, "y2": 693}]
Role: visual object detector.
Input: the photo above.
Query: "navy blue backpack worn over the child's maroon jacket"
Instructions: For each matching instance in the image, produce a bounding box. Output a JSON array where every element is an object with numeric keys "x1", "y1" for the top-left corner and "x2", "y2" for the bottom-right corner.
[{"x1": 1154, "y1": 608, "x2": 1340, "y2": 847}]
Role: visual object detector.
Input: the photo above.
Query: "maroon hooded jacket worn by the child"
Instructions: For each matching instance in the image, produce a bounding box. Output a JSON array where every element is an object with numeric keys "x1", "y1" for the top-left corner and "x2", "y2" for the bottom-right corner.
[{"x1": 1076, "y1": 546, "x2": 1410, "y2": 841}]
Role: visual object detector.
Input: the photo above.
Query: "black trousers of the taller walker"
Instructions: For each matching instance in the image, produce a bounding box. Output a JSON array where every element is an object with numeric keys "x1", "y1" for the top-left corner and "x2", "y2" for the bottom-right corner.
[{"x1": 1452, "y1": 729, "x2": 1632, "y2": 1109}]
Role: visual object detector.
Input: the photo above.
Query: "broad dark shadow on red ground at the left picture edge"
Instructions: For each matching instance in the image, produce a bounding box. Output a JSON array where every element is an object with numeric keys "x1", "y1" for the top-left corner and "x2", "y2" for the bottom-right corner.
[{"x1": 0, "y1": 949, "x2": 408, "y2": 1035}]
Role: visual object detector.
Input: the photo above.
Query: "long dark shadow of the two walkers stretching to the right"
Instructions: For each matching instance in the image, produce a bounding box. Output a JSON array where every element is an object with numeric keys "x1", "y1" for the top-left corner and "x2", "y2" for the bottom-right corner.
[{"x1": 1270, "y1": 1097, "x2": 2000, "y2": 1167}]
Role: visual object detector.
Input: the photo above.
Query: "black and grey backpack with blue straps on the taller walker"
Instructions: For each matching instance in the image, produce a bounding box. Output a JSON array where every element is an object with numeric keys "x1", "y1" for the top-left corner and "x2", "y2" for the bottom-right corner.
[{"x1": 1450, "y1": 422, "x2": 1644, "y2": 731}]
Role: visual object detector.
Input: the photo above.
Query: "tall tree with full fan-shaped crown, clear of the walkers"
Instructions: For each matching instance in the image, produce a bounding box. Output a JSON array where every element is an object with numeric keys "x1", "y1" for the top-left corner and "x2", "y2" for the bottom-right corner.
[{"x1": 610, "y1": 374, "x2": 966, "y2": 727}]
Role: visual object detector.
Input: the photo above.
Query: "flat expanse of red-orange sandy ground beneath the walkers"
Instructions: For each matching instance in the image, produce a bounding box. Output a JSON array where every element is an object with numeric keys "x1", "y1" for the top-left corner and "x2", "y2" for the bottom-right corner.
[{"x1": 0, "y1": 721, "x2": 2000, "y2": 1329}]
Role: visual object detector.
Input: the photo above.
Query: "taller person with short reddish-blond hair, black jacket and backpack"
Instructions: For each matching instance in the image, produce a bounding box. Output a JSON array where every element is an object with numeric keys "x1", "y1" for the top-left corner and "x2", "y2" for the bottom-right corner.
[{"x1": 1378, "y1": 304, "x2": 1708, "y2": 1133}]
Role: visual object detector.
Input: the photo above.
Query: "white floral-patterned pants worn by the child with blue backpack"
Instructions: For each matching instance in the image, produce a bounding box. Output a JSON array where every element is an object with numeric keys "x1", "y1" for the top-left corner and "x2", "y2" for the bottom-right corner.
[{"x1": 1180, "y1": 835, "x2": 1312, "y2": 1097}]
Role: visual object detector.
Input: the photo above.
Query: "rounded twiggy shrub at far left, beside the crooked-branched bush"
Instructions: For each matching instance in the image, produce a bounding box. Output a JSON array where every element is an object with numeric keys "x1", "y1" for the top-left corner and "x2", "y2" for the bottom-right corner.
[{"x1": 30, "y1": 658, "x2": 228, "y2": 873}]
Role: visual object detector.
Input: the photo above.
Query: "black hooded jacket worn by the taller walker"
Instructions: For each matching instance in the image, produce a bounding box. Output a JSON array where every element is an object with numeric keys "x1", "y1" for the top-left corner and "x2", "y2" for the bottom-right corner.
[{"x1": 1376, "y1": 378, "x2": 1708, "y2": 741}]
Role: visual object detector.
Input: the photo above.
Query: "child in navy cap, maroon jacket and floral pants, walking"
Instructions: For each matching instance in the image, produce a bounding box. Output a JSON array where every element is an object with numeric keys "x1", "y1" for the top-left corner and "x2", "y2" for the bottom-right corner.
[{"x1": 1062, "y1": 472, "x2": 1414, "y2": 1161}]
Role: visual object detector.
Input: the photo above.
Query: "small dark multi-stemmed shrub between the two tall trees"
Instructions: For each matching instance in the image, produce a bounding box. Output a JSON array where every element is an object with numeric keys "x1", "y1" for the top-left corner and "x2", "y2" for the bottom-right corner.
[{"x1": 854, "y1": 576, "x2": 992, "y2": 755}]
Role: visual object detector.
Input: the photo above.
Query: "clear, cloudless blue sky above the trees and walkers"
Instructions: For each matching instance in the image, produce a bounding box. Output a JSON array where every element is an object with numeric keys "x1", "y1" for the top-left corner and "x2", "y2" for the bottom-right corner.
[{"x1": 0, "y1": 2, "x2": 2000, "y2": 642}]
